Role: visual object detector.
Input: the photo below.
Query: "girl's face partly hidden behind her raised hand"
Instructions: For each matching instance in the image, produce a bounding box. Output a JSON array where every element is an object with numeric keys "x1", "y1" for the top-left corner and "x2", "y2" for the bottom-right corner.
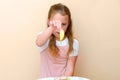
[{"x1": 48, "y1": 13, "x2": 69, "y2": 40}]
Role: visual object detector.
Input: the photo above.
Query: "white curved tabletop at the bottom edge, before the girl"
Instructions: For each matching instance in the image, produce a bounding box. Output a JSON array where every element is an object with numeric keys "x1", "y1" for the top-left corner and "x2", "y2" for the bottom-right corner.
[{"x1": 38, "y1": 76, "x2": 90, "y2": 80}]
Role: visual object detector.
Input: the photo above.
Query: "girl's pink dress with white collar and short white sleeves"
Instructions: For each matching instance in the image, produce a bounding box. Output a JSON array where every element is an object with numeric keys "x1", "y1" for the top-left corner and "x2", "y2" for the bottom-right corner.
[{"x1": 40, "y1": 38, "x2": 79, "y2": 78}]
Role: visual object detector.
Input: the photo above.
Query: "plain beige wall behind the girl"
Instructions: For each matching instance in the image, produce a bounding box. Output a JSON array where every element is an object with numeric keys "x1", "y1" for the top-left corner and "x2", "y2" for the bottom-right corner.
[{"x1": 0, "y1": 0, "x2": 120, "y2": 80}]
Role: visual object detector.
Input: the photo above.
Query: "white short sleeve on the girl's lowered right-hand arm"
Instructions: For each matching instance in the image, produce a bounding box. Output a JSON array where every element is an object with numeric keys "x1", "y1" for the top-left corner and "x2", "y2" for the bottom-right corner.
[{"x1": 69, "y1": 39, "x2": 79, "y2": 56}]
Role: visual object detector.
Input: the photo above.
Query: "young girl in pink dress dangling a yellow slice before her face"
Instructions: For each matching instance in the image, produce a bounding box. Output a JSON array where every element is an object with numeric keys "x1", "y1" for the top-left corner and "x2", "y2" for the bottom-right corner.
[{"x1": 36, "y1": 3, "x2": 79, "y2": 78}]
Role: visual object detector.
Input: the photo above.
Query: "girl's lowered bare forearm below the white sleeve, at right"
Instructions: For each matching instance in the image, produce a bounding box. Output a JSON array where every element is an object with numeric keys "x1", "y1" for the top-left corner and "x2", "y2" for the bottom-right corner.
[{"x1": 65, "y1": 56, "x2": 77, "y2": 76}]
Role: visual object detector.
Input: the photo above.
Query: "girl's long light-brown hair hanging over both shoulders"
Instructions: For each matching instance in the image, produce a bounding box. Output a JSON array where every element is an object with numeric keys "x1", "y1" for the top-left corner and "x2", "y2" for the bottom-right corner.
[{"x1": 48, "y1": 3, "x2": 73, "y2": 56}]
